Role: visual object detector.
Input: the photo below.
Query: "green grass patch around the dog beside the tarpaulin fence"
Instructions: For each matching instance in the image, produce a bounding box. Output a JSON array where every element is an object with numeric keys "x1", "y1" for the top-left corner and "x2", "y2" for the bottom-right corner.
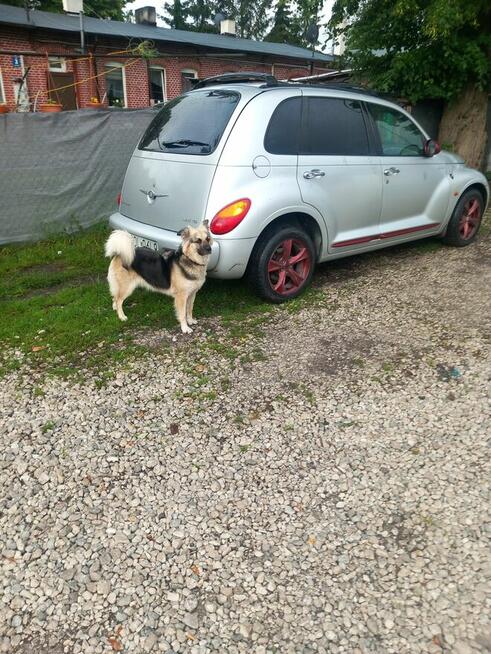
[{"x1": 0, "y1": 225, "x2": 272, "y2": 379}]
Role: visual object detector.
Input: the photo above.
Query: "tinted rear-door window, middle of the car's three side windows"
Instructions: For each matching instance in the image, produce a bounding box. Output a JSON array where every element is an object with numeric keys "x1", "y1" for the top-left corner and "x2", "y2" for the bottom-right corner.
[{"x1": 300, "y1": 97, "x2": 369, "y2": 156}]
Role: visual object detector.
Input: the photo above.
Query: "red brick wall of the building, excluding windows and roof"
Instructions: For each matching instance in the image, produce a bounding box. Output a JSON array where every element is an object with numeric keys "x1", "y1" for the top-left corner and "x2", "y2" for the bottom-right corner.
[{"x1": 0, "y1": 27, "x2": 328, "y2": 109}]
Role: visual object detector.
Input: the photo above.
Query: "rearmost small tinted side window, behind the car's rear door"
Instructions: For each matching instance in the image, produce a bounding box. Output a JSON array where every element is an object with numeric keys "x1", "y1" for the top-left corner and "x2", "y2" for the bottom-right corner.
[{"x1": 264, "y1": 97, "x2": 302, "y2": 154}]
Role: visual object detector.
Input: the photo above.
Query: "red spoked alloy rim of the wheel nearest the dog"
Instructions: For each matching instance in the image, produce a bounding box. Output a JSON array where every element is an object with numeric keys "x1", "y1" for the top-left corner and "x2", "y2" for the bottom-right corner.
[{"x1": 268, "y1": 238, "x2": 312, "y2": 296}]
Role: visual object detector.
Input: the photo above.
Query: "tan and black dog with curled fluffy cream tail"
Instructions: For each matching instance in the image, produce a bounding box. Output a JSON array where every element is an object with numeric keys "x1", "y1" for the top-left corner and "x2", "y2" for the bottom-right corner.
[{"x1": 105, "y1": 220, "x2": 213, "y2": 334}]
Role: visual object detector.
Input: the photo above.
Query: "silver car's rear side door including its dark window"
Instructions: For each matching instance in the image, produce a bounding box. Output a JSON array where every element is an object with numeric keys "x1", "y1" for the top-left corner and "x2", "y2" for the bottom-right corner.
[{"x1": 298, "y1": 95, "x2": 382, "y2": 254}]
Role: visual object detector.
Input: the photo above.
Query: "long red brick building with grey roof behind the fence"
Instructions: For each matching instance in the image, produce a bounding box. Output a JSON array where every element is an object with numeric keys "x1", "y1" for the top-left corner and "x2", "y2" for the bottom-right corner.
[{"x1": 0, "y1": 4, "x2": 333, "y2": 111}]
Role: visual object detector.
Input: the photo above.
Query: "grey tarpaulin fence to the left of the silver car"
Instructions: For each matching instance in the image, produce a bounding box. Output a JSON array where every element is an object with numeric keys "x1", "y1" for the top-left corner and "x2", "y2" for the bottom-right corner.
[{"x1": 0, "y1": 109, "x2": 155, "y2": 244}]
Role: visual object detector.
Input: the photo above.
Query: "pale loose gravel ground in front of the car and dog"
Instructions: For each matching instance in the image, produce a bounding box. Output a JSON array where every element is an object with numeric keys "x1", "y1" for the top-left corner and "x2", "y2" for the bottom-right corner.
[{"x1": 0, "y1": 222, "x2": 491, "y2": 654}]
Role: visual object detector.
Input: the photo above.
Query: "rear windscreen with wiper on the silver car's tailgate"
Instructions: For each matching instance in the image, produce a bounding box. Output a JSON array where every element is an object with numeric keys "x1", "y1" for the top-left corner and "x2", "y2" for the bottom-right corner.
[{"x1": 138, "y1": 89, "x2": 240, "y2": 155}]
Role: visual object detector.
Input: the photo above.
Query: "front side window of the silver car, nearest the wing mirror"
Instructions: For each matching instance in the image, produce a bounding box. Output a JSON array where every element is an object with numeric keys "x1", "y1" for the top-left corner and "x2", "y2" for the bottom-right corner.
[{"x1": 368, "y1": 103, "x2": 425, "y2": 157}]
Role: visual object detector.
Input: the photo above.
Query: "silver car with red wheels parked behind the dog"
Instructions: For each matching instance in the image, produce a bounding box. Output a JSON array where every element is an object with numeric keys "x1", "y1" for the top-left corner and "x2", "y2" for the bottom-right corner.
[{"x1": 110, "y1": 74, "x2": 489, "y2": 302}]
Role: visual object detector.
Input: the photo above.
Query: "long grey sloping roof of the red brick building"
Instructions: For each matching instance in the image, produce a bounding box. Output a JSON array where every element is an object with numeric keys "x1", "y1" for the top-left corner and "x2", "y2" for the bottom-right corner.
[{"x1": 0, "y1": 4, "x2": 334, "y2": 63}]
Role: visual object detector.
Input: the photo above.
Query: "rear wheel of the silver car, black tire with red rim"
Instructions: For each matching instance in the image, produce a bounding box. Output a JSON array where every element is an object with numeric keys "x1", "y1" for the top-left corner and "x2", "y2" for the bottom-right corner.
[{"x1": 248, "y1": 225, "x2": 316, "y2": 304}]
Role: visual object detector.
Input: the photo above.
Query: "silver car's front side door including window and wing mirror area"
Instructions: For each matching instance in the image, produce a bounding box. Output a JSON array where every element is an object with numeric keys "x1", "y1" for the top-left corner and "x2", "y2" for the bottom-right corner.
[{"x1": 367, "y1": 102, "x2": 450, "y2": 242}]
